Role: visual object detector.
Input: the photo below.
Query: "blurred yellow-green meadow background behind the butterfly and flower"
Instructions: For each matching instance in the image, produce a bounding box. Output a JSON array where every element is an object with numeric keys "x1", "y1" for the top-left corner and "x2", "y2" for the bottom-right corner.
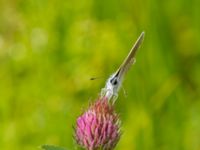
[{"x1": 0, "y1": 0, "x2": 200, "y2": 150}]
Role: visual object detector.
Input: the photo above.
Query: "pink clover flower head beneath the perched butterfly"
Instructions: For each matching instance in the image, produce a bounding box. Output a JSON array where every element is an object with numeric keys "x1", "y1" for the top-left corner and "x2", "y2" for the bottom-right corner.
[{"x1": 75, "y1": 97, "x2": 121, "y2": 150}]
